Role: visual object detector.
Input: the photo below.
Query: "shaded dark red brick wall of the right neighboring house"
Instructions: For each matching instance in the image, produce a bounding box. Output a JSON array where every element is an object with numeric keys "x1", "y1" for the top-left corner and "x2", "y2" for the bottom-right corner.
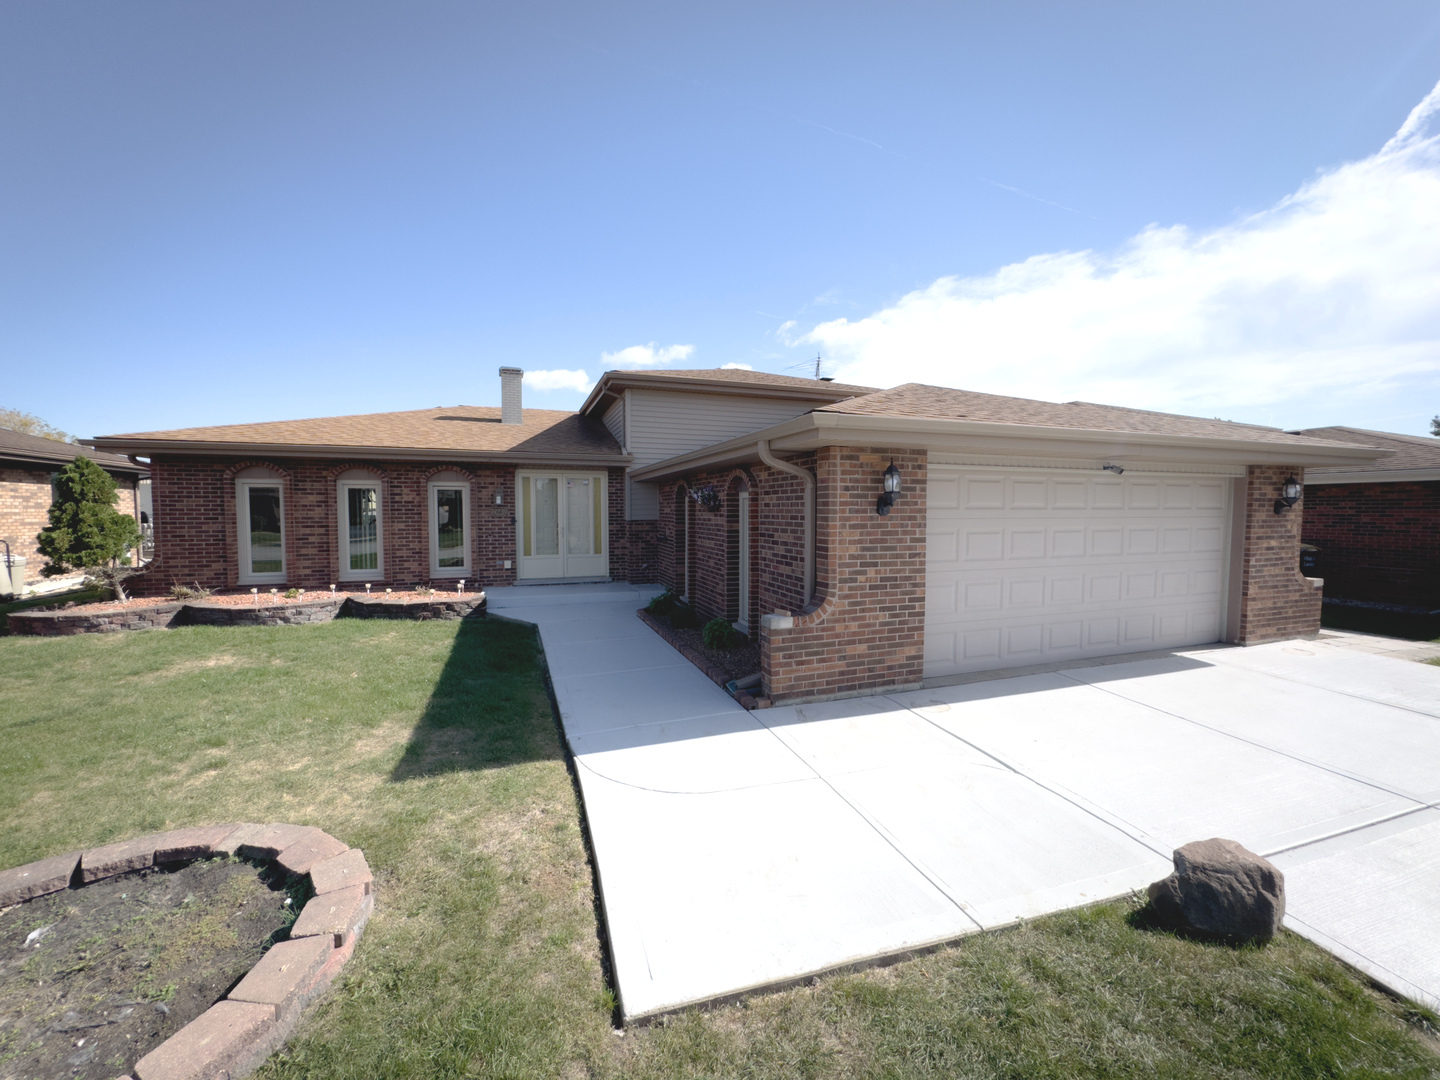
[{"x1": 1303, "y1": 481, "x2": 1440, "y2": 609}]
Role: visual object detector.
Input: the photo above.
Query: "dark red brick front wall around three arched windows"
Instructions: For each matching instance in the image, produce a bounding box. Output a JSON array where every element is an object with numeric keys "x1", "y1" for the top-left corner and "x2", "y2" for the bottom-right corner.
[{"x1": 145, "y1": 458, "x2": 636, "y2": 593}]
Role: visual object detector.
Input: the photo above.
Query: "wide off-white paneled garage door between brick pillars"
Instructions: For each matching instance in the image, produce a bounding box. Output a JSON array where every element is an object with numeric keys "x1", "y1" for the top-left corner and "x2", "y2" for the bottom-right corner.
[{"x1": 924, "y1": 465, "x2": 1230, "y2": 677}]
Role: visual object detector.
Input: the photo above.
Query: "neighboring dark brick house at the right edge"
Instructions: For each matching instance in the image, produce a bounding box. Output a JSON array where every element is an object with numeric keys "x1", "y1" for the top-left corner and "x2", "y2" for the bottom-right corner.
[{"x1": 1296, "y1": 426, "x2": 1440, "y2": 613}]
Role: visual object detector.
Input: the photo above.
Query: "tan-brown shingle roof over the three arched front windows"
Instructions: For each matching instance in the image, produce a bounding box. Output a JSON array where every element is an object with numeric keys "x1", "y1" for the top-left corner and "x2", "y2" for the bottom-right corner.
[{"x1": 94, "y1": 405, "x2": 622, "y2": 458}]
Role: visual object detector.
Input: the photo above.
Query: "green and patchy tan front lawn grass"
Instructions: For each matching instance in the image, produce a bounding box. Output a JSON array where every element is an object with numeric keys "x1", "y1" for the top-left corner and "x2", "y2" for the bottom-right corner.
[{"x1": 0, "y1": 619, "x2": 1440, "y2": 1080}]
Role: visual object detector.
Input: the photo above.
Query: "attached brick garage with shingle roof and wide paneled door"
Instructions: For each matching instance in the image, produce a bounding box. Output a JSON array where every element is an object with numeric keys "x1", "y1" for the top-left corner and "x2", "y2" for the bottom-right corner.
[{"x1": 632, "y1": 383, "x2": 1382, "y2": 703}]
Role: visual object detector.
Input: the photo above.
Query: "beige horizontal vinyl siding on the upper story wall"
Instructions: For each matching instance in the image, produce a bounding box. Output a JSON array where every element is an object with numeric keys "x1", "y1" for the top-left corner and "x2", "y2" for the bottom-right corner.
[{"x1": 622, "y1": 387, "x2": 821, "y2": 521}]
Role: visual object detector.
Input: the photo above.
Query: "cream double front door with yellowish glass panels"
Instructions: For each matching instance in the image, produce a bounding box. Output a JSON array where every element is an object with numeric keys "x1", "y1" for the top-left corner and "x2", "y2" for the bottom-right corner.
[{"x1": 516, "y1": 471, "x2": 611, "y2": 580}]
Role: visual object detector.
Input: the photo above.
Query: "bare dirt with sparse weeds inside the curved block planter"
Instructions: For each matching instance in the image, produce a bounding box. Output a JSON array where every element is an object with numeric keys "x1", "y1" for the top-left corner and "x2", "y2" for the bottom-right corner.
[{"x1": 0, "y1": 858, "x2": 292, "y2": 1080}]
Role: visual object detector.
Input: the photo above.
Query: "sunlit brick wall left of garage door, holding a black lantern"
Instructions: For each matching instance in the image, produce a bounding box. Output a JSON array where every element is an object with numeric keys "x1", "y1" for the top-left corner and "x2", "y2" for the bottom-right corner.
[{"x1": 760, "y1": 446, "x2": 926, "y2": 701}]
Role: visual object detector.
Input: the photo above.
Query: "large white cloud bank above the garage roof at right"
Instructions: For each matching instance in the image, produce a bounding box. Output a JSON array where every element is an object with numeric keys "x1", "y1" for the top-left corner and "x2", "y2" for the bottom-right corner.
[{"x1": 806, "y1": 77, "x2": 1440, "y2": 426}]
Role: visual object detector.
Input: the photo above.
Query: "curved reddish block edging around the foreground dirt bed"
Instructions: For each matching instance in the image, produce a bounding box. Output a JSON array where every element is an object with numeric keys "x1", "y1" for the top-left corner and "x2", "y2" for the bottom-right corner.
[{"x1": 0, "y1": 822, "x2": 374, "y2": 1080}]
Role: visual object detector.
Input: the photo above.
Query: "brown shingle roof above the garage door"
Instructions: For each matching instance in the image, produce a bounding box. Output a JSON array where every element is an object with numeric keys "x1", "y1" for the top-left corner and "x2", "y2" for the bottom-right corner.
[{"x1": 815, "y1": 383, "x2": 1375, "y2": 445}]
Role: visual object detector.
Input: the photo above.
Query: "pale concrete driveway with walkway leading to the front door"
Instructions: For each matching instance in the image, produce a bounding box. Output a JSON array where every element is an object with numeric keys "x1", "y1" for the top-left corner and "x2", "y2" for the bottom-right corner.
[{"x1": 490, "y1": 585, "x2": 1440, "y2": 1018}]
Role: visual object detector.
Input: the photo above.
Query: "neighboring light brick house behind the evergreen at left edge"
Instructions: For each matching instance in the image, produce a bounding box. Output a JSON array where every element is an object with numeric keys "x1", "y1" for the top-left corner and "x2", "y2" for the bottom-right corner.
[{"x1": 0, "y1": 428, "x2": 148, "y2": 596}]
